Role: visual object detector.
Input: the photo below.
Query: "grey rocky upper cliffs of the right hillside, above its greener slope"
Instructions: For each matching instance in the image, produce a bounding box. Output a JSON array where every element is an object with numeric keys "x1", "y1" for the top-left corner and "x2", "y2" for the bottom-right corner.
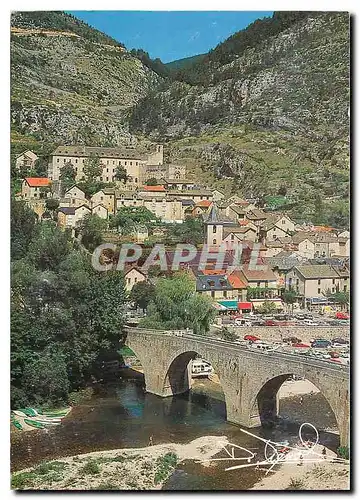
[{"x1": 133, "y1": 13, "x2": 349, "y2": 142}]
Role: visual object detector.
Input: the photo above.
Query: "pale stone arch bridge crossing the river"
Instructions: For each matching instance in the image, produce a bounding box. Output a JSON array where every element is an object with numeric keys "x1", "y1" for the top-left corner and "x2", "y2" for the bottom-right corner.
[{"x1": 125, "y1": 328, "x2": 350, "y2": 446}]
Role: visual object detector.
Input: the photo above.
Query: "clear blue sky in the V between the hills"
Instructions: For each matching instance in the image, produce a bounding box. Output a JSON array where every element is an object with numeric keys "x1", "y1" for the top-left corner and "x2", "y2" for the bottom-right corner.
[{"x1": 67, "y1": 10, "x2": 272, "y2": 62}]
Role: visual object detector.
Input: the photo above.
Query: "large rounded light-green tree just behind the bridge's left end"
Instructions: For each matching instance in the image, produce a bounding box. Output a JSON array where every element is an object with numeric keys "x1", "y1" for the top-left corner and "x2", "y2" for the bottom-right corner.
[{"x1": 140, "y1": 273, "x2": 215, "y2": 335}]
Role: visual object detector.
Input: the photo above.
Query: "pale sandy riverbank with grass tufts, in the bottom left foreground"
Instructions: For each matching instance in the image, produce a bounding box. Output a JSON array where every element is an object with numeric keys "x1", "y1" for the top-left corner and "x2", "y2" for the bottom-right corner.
[{"x1": 12, "y1": 436, "x2": 228, "y2": 490}]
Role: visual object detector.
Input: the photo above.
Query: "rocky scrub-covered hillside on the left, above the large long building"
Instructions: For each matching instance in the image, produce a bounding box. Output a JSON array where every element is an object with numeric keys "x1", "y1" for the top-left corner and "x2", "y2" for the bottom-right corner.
[{"x1": 11, "y1": 12, "x2": 160, "y2": 146}]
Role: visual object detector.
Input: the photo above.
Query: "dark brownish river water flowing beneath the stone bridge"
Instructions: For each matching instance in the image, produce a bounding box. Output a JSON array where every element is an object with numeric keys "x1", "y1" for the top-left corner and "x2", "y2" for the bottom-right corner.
[{"x1": 11, "y1": 379, "x2": 339, "y2": 490}]
